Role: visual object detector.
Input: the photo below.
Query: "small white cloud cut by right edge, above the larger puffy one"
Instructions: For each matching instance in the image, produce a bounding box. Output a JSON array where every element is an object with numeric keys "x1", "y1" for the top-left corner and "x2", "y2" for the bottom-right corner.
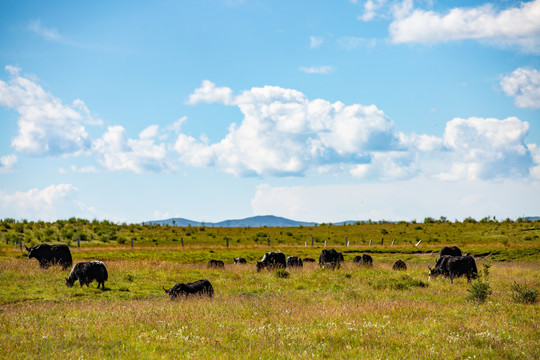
[{"x1": 501, "y1": 68, "x2": 540, "y2": 109}]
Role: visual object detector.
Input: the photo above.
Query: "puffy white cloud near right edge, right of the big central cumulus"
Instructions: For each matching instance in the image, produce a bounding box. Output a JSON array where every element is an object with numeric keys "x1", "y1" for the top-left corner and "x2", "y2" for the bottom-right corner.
[{"x1": 440, "y1": 117, "x2": 532, "y2": 180}]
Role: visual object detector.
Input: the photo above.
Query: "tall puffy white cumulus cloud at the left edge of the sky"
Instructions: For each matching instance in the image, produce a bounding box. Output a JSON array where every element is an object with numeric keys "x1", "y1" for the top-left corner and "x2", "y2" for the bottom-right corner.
[{"x1": 0, "y1": 66, "x2": 97, "y2": 156}]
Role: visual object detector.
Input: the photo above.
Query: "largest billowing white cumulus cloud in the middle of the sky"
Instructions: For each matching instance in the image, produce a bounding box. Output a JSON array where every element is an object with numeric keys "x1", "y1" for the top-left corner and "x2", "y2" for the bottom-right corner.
[{"x1": 180, "y1": 81, "x2": 396, "y2": 176}]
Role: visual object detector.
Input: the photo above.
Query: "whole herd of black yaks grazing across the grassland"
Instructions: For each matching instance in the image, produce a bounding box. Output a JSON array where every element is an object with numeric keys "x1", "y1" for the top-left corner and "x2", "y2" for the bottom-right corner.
[{"x1": 26, "y1": 244, "x2": 478, "y2": 299}]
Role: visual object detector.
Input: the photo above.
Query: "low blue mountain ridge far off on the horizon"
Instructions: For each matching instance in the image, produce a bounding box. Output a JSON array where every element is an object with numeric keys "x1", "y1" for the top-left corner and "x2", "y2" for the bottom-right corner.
[{"x1": 144, "y1": 215, "x2": 317, "y2": 227}]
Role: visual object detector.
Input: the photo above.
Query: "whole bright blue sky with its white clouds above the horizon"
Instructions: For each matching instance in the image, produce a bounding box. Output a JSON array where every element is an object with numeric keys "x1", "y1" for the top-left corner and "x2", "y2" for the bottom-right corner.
[{"x1": 0, "y1": 0, "x2": 540, "y2": 222}]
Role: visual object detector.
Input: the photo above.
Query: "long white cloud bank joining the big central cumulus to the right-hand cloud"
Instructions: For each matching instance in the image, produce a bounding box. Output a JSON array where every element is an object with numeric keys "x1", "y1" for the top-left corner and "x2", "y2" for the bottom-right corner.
[{"x1": 181, "y1": 82, "x2": 534, "y2": 181}]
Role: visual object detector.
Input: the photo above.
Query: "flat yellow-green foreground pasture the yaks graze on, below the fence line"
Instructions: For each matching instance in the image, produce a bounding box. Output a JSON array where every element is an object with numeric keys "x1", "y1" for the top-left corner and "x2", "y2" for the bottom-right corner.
[{"x1": 0, "y1": 243, "x2": 540, "y2": 359}]
